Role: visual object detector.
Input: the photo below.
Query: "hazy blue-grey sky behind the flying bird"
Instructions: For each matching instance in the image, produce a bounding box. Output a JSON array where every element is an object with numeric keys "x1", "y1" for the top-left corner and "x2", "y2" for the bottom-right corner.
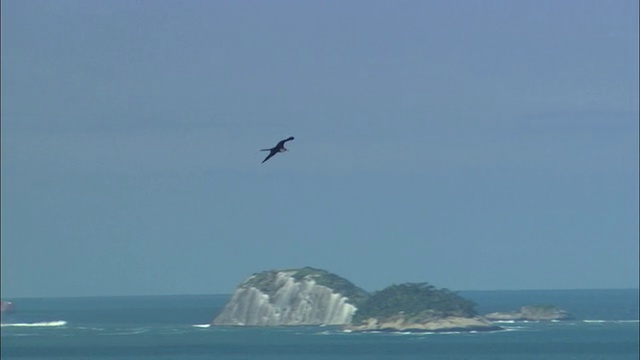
[{"x1": 1, "y1": 0, "x2": 639, "y2": 299}]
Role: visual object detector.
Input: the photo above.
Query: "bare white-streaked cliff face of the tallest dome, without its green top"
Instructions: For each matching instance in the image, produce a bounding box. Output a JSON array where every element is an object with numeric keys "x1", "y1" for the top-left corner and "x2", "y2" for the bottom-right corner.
[{"x1": 213, "y1": 271, "x2": 356, "y2": 326}]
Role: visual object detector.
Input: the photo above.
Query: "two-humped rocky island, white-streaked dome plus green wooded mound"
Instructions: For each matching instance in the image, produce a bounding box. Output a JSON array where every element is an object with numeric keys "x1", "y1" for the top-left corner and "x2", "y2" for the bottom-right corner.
[{"x1": 212, "y1": 267, "x2": 501, "y2": 332}]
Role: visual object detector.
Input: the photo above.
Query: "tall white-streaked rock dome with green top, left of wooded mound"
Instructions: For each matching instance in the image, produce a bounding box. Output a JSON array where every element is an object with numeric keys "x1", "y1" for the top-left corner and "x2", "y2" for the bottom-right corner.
[{"x1": 212, "y1": 267, "x2": 369, "y2": 326}]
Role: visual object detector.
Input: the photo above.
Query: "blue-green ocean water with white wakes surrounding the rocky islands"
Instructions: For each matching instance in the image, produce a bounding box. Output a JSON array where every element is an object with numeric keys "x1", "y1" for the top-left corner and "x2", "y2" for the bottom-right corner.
[{"x1": 1, "y1": 289, "x2": 639, "y2": 360}]
